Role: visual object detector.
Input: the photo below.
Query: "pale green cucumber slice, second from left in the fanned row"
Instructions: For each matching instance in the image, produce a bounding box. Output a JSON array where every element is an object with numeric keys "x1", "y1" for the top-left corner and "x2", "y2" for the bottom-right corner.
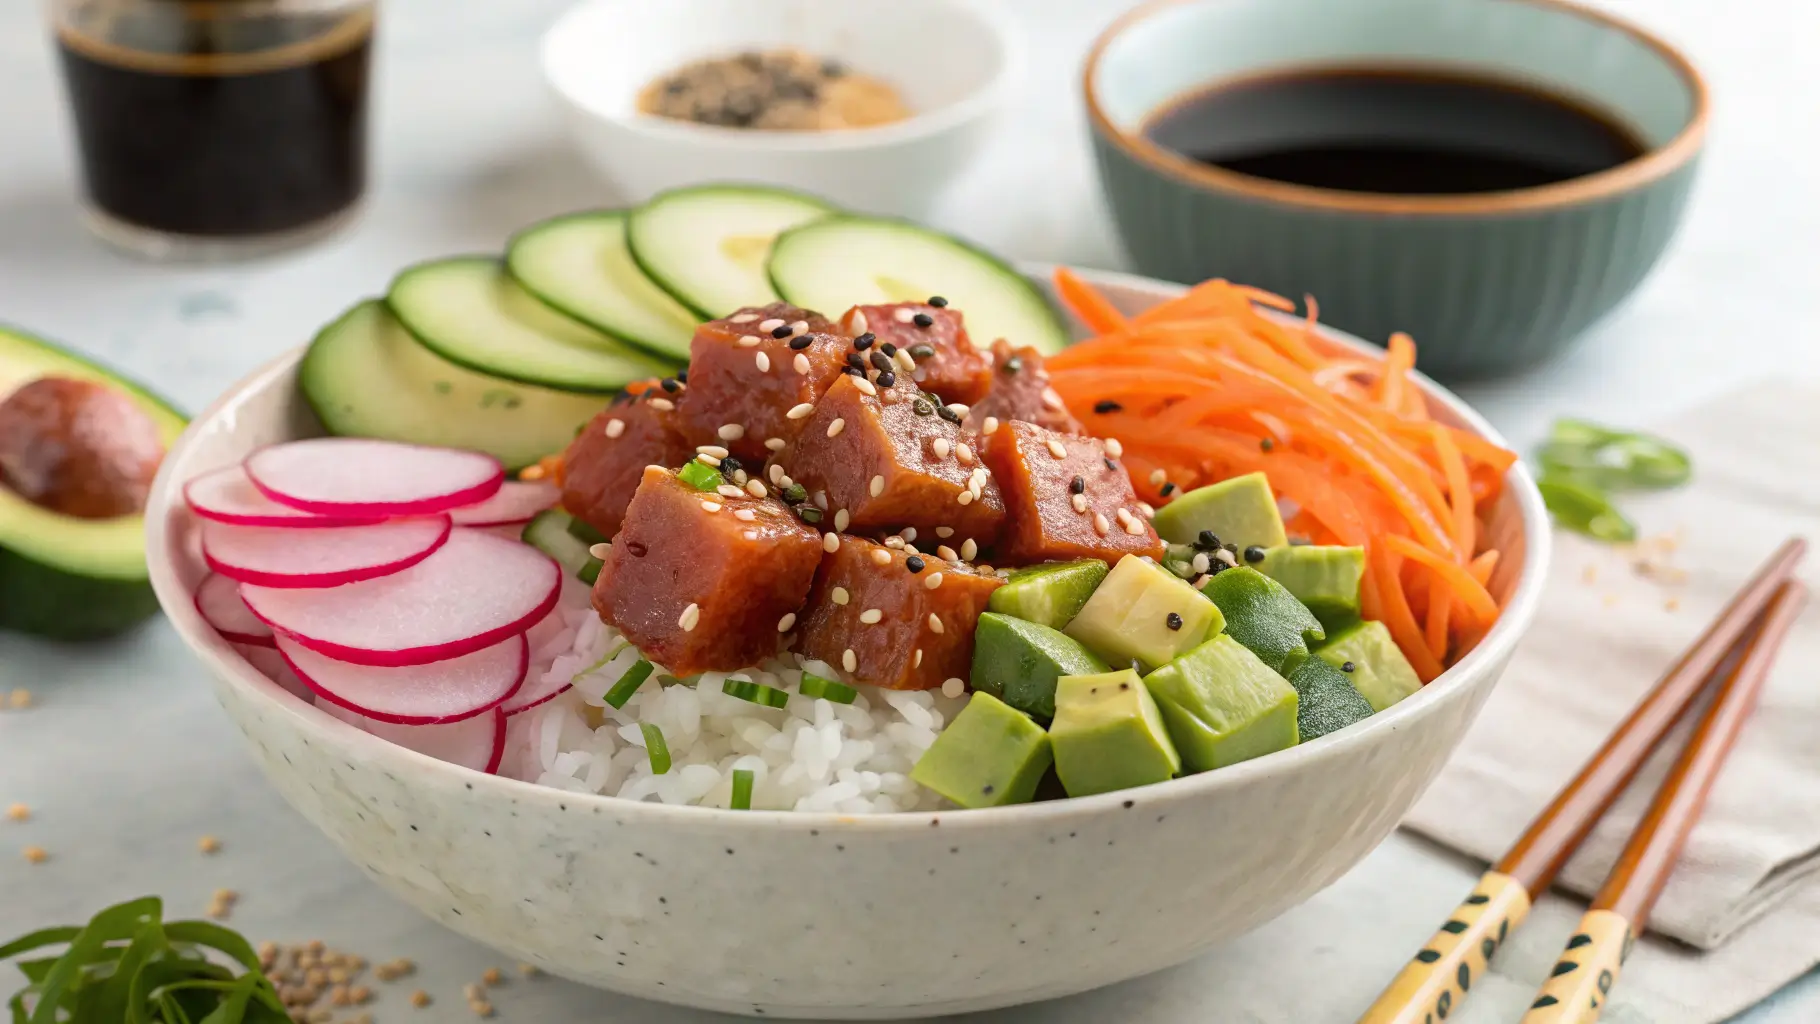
[{"x1": 386, "y1": 256, "x2": 675, "y2": 395}]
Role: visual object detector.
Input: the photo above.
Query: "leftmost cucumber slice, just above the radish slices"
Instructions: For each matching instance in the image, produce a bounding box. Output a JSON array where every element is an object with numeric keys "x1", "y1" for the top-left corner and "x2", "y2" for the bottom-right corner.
[{"x1": 297, "y1": 300, "x2": 601, "y2": 469}]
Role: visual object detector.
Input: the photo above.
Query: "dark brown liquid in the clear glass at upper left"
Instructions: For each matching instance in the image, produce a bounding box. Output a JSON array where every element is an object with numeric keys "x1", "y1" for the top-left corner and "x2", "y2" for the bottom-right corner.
[{"x1": 56, "y1": 4, "x2": 373, "y2": 238}]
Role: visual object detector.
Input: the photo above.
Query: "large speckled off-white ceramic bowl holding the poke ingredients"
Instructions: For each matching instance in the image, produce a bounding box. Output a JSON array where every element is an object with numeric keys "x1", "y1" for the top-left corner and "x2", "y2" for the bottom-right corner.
[{"x1": 146, "y1": 267, "x2": 1549, "y2": 1019}]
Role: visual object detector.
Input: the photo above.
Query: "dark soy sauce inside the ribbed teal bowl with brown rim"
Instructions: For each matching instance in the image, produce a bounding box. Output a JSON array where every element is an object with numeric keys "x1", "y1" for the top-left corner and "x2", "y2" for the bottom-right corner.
[{"x1": 1145, "y1": 67, "x2": 1647, "y2": 195}]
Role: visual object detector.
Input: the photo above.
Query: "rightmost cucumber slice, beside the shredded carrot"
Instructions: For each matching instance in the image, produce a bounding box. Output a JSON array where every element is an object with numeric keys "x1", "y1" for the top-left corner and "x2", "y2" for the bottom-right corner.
[{"x1": 770, "y1": 213, "x2": 1068, "y2": 353}]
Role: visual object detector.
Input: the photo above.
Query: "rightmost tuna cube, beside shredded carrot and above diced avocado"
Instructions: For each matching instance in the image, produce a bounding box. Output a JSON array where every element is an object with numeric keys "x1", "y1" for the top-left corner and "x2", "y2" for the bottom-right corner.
[{"x1": 981, "y1": 420, "x2": 1163, "y2": 564}]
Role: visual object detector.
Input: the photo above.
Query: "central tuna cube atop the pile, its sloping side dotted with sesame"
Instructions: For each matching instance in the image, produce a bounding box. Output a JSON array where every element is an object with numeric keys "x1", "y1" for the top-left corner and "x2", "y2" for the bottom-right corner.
[{"x1": 777, "y1": 375, "x2": 1005, "y2": 546}]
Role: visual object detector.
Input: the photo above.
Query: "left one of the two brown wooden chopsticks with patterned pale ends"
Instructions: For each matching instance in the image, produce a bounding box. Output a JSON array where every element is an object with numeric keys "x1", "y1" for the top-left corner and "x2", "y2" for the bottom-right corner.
[{"x1": 1360, "y1": 537, "x2": 1807, "y2": 1024}]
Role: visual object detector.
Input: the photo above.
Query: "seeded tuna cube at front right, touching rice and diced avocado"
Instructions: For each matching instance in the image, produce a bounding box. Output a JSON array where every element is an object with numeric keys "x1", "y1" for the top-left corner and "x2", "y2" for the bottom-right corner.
[{"x1": 797, "y1": 537, "x2": 1001, "y2": 689}]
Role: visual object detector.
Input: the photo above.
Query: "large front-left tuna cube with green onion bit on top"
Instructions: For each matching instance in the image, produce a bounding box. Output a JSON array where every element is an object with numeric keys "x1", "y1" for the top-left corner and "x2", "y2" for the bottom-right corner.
[{"x1": 593, "y1": 467, "x2": 823, "y2": 675}]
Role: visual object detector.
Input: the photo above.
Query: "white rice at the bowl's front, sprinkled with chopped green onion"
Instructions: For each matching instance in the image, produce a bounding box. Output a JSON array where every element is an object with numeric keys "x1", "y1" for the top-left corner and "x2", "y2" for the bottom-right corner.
[{"x1": 501, "y1": 587, "x2": 966, "y2": 815}]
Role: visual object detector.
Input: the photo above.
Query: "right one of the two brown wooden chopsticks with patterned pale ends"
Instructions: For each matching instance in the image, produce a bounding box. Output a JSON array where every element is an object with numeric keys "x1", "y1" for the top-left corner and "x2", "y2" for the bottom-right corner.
[{"x1": 1523, "y1": 580, "x2": 1807, "y2": 1024}]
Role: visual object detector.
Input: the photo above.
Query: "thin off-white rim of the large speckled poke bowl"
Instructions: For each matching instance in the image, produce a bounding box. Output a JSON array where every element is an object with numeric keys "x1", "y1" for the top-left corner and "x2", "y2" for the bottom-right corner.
[{"x1": 146, "y1": 262, "x2": 1552, "y2": 831}]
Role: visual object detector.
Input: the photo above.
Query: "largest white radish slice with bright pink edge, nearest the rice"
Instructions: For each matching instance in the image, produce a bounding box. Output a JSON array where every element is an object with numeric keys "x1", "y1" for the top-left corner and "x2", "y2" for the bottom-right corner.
[{"x1": 240, "y1": 527, "x2": 562, "y2": 666}]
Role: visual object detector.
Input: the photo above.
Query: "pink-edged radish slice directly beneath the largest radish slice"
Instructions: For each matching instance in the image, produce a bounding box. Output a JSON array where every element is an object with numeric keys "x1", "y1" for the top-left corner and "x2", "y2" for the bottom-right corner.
[{"x1": 278, "y1": 633, "x2": 531, "y2": 726}]
